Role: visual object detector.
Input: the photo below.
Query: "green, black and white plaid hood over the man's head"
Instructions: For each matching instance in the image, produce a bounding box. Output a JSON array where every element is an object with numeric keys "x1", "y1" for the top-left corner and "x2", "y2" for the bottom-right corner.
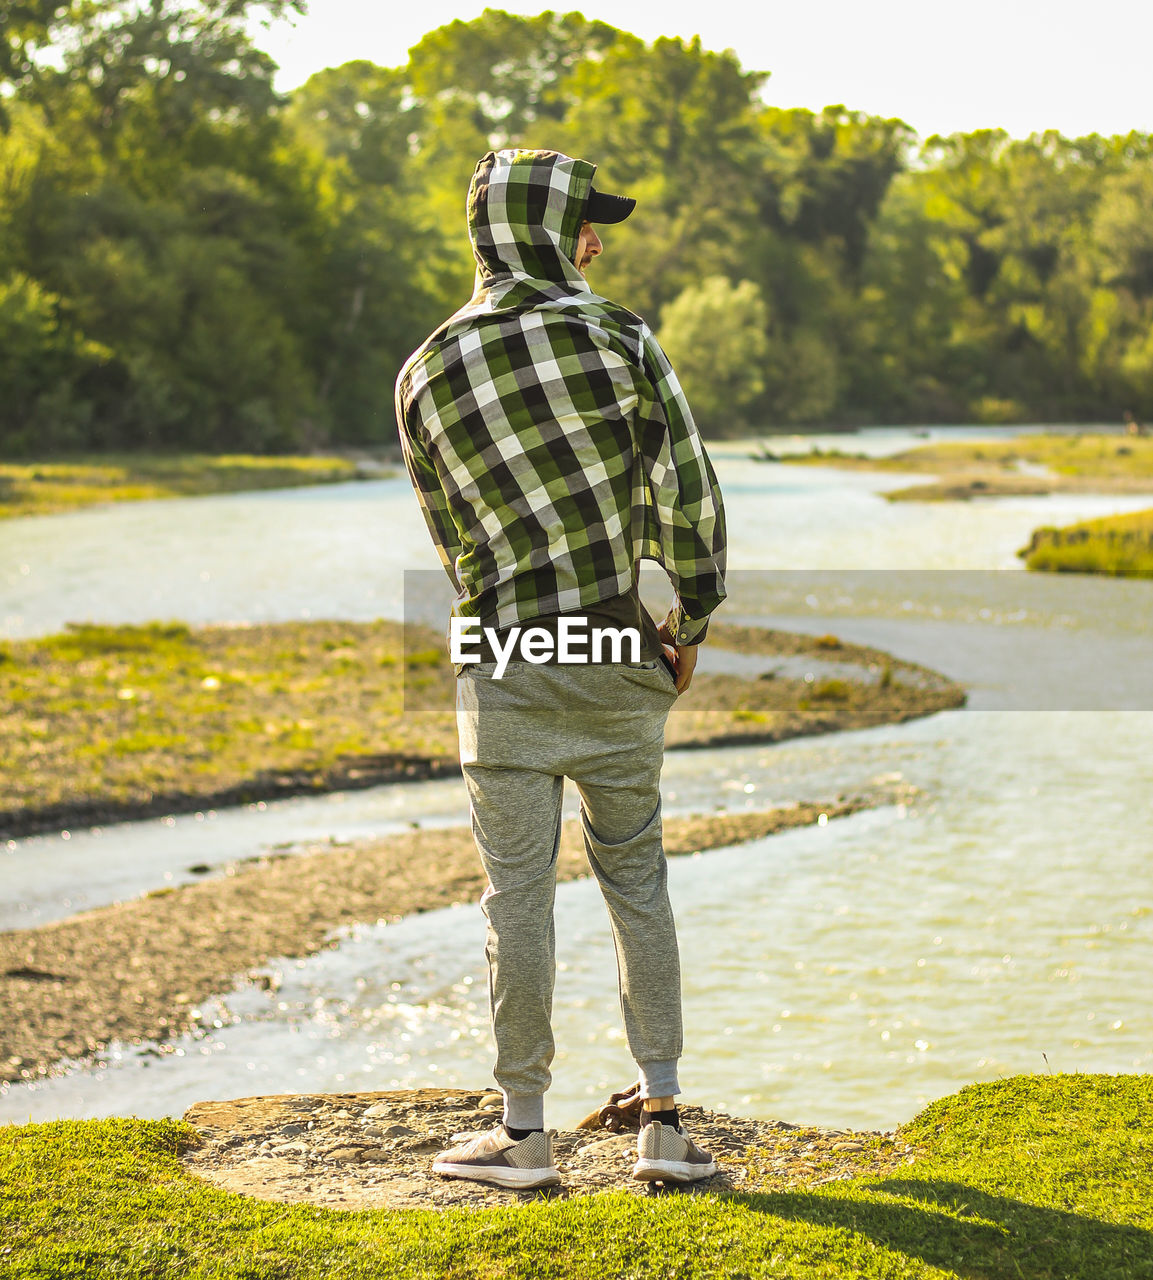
[{"x1": 468, "y1": 150, "x2": 596, "y2": 289}]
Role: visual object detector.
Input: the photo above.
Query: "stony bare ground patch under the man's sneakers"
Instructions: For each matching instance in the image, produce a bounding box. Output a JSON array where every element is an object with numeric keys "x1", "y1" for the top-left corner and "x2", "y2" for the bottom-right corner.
[{"x1": 182, "y1": 1089, "x2": 916, "y2": 1210}]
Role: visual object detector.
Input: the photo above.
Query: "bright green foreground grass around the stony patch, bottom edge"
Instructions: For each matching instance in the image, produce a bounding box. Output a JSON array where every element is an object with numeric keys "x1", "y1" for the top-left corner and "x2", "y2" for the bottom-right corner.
[{"x1": 0, "y1": 1075, "x2": 1153, "y2": 1280}]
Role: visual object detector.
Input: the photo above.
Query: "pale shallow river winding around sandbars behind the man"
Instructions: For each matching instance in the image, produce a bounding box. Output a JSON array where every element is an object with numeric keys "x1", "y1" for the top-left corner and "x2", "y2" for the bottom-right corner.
[{"x1": 0, "y1": 433, "x2": 1153, "y2": 1128}]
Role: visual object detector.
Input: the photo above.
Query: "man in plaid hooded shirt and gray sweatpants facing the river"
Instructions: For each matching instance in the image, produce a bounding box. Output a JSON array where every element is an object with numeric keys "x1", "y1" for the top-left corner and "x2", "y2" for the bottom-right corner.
[{"x1": 397, "y1": 151, "x2": 724, "y2": 1188}]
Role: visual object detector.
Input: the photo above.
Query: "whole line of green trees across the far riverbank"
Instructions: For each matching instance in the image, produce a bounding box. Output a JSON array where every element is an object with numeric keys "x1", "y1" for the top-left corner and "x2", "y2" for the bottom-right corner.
[{"x1": 0, "y1": 0, "x2": 1153, "y2": 454}]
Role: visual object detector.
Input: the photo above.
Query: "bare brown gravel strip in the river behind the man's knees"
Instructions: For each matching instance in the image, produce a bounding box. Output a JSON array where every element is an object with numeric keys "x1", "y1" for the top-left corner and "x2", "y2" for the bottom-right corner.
[{"x1": 0, "y1": 785, "x2": 912, "y2": 1082}]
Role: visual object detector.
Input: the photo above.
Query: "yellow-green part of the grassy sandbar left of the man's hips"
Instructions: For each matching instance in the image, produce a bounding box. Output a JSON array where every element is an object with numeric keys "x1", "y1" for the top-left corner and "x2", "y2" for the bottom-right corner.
[{"x1": 0, "y1": 622, "x2": 456, "y2": 832}]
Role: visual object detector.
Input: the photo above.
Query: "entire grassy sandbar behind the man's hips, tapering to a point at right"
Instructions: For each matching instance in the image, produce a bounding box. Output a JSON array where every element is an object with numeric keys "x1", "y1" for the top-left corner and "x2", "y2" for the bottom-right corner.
[{"x1": 0, "y1": 621, "x2": 965, "y2": 840}]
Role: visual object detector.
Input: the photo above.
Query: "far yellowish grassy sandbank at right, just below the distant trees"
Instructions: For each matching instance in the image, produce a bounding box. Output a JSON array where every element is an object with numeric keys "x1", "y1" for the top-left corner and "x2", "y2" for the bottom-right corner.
[{"x1": 765, "y1": 434, "x2": 1153, "y2": 502}]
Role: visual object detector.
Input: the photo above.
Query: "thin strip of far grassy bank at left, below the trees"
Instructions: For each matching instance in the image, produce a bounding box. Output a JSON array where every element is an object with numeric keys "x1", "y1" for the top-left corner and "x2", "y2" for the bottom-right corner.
[{"x1": 0, "y1": 453, "x2": 378, "y2": 518}]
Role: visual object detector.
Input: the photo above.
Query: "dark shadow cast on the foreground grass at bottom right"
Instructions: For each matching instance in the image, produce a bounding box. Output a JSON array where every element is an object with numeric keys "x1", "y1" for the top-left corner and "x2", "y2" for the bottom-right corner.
[{"x1": 731, "y1": 1179, "x2": 1153, "y2": 1280}]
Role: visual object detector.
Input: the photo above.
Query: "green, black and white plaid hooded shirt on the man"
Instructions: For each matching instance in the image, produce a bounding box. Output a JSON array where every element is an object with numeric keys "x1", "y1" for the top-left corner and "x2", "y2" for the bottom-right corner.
[{"x1": 397, "y1": 151, "x2": 724, "y2": 644}]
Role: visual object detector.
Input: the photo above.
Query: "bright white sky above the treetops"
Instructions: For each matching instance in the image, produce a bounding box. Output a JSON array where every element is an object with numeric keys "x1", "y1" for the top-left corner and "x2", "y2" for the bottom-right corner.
[{"x1": 255, "y1": 0, "x2": 1153, "y2": 137}]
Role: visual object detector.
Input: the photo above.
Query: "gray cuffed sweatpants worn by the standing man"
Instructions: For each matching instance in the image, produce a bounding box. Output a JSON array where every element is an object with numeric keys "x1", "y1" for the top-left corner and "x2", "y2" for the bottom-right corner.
[{"x1": 457, "y1": 662, "x2": 681, "y2": 1129}]
